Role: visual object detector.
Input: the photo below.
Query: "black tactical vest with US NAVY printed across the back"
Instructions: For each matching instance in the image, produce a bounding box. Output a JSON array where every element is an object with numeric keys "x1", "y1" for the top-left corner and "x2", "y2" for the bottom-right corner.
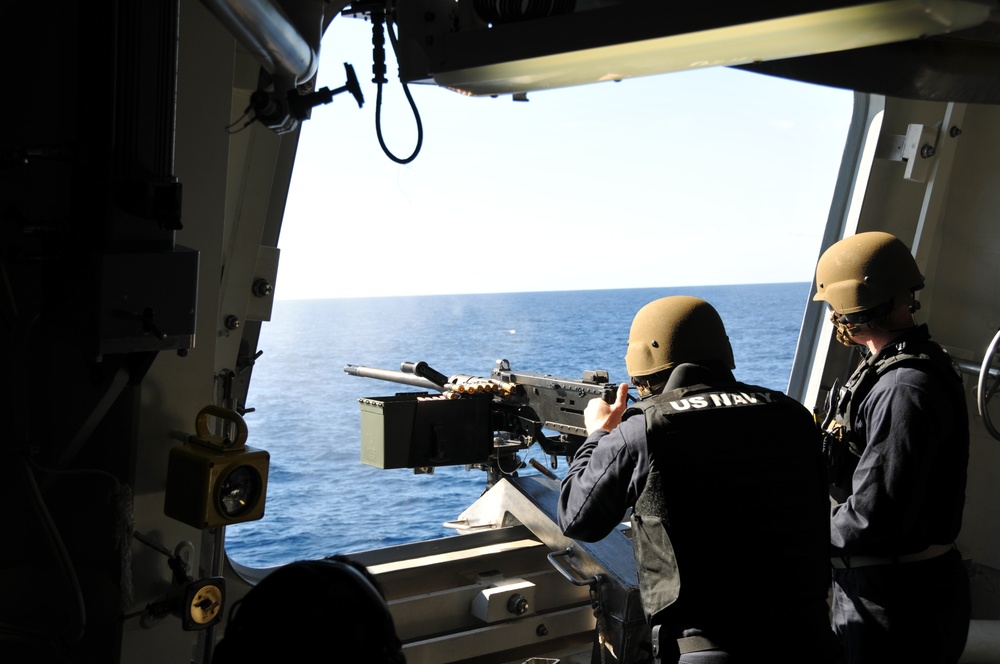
[{"x1": 625, "y1": 383, "x2": 829, "y2": 630}]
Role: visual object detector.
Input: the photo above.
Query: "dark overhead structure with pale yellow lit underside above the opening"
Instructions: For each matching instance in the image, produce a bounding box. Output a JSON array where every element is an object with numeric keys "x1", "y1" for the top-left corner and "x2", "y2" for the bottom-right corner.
[{"x1": 380, "y1": 0, "x2": 1000, "y2": 103}]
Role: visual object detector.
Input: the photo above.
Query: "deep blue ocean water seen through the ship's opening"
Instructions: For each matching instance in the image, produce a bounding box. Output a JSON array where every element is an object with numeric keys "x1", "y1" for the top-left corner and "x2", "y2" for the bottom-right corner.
[{"x1": 226, "y1": 283, "x2": 809, "y2": 567}]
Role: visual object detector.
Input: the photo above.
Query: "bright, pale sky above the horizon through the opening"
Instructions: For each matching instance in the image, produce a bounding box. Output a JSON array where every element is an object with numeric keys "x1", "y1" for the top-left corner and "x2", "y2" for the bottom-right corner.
[{"x1": 275, "y1": 18, "x2": 852, "y2": 299}]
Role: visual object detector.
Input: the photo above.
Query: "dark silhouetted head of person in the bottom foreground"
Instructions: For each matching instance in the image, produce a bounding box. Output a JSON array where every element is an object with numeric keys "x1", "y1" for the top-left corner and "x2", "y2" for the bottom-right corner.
[{"x1": 212, "y1": 556, "x2": 406, "y2": 664}]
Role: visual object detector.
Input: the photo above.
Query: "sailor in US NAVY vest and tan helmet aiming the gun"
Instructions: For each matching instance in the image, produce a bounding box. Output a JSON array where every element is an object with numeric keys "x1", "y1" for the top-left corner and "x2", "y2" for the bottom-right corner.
[{"x1": 558, "y1": 296, "x2": 841, "y2": 664}]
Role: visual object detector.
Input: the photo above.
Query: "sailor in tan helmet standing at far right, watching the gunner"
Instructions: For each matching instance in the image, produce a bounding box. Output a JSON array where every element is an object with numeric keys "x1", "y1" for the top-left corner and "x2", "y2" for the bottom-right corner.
[{"x1": 813, "y1": 232, "x2": 970, "y2": 664}]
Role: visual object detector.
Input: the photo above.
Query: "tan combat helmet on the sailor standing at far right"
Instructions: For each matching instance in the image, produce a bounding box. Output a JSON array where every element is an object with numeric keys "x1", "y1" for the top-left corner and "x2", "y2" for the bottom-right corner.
[{"x1": 813, "y1": 231, "x2": 924, "y2": 323}]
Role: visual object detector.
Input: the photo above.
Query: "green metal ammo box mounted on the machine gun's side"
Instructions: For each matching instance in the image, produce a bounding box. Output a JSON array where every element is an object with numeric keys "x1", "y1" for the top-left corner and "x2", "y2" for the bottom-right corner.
[{"x1": 358, "y1": 392, "x2": 493, "y2": 468}]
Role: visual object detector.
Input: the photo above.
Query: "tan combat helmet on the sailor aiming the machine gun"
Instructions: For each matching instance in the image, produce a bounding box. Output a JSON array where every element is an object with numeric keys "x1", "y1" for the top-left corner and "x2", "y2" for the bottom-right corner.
[{"x1": 625, "y1": 295, "x2": 736, "y2": 378}]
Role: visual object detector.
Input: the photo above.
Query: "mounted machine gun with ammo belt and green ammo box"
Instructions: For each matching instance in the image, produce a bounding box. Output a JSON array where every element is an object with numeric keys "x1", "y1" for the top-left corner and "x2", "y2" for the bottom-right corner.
[{"x1": 344, "y1": 360, "x2": 618, "y2": 485}]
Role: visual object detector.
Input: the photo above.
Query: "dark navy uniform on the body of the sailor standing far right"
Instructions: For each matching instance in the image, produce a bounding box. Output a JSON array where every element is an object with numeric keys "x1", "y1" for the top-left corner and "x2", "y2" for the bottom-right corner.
[{"x1": 830, "y1": 325, "x2": 970, "y2": 664}]
